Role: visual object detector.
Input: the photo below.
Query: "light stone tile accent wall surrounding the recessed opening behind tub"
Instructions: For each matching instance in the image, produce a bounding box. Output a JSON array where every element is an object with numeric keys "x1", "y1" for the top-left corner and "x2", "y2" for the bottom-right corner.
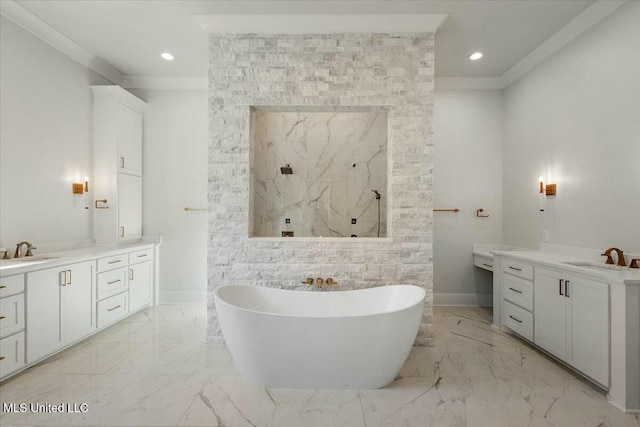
[{"x1": 207, "y1": 33, "x2": 434, "y2": 345}]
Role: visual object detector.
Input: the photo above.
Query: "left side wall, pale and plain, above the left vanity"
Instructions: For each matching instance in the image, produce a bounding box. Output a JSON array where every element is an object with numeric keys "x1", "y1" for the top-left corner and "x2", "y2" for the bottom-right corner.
[{"x1": 0, "y1": 16, "x2": 108, "y2": 249}]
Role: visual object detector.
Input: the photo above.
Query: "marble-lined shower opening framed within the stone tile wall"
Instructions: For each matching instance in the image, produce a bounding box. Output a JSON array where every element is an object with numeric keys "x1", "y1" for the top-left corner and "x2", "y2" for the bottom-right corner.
[{"x1": 249, "y1": 107, "x2": 388, "y2": 238}]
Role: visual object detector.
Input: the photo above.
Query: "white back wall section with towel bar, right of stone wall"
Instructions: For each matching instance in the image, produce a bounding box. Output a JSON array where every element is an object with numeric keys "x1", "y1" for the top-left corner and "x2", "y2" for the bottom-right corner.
[{"x1": 433, "y1": 90, "x2": 503, "y2": 305}]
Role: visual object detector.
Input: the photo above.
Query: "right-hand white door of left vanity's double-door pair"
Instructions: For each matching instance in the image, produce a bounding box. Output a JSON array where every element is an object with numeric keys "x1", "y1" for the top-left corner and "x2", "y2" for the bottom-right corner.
[{"x1": 61, "y1": 261, "x2": 95, "y2": 344}]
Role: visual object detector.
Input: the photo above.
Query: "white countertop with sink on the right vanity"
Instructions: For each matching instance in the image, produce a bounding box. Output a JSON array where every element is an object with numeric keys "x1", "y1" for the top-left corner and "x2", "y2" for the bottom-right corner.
[{"x1": 492, "y1": 250, "x2": 640, "y2": 285}]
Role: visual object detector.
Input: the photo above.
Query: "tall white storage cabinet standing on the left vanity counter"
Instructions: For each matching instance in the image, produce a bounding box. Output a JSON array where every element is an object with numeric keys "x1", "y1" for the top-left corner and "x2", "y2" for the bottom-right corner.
[{"x1": 91, "y1": 86, "x2": 147, "y2": 246}]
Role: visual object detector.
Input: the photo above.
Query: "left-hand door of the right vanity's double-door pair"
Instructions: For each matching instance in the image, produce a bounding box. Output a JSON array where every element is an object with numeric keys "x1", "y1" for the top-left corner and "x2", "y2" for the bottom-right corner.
[{"x1": 534, "y1": 268, "x2": 567, "y2": 360}]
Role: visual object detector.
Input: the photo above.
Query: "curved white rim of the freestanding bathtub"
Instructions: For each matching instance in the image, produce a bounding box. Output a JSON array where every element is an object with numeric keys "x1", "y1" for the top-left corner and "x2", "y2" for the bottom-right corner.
[{"x1": 213, "y1": 284, "x2": 427, "y2": 319}]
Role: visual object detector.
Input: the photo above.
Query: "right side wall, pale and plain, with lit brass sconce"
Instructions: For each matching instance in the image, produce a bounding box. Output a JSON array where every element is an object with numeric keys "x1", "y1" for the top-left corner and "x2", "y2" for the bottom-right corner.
[{"x1": 504, "y1": 1, "x2": 640, "y2": 253}]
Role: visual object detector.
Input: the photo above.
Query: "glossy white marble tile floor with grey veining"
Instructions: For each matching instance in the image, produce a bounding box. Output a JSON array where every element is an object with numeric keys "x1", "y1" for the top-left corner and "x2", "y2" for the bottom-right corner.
[{"x1": 0, "y1": 305, "x2": 640, "y2": 427}]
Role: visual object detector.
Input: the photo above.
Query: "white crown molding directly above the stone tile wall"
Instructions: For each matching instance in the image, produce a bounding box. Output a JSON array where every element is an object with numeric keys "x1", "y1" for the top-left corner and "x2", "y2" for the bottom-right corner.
[{"x1": 196, "y1": 13, "x2": 448, "y2": 34}]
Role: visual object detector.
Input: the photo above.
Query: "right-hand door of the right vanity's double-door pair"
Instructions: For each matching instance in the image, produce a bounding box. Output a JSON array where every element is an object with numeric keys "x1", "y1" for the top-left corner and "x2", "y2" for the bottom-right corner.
[{"x1": 567, "y1": 276, "x2": 609, "y2": 386}]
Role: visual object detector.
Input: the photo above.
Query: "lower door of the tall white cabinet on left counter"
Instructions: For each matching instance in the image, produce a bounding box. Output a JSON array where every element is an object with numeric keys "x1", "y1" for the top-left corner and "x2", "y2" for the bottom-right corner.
[{"x1": 118, "y1": 173, "x2": 142, "y2": 240}]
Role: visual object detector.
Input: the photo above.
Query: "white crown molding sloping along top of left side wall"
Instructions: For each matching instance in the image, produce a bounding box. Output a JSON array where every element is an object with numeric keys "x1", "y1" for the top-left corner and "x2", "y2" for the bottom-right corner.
[{"x1": 0, "y1": 0, "x2": 124, "y2": 84}]
